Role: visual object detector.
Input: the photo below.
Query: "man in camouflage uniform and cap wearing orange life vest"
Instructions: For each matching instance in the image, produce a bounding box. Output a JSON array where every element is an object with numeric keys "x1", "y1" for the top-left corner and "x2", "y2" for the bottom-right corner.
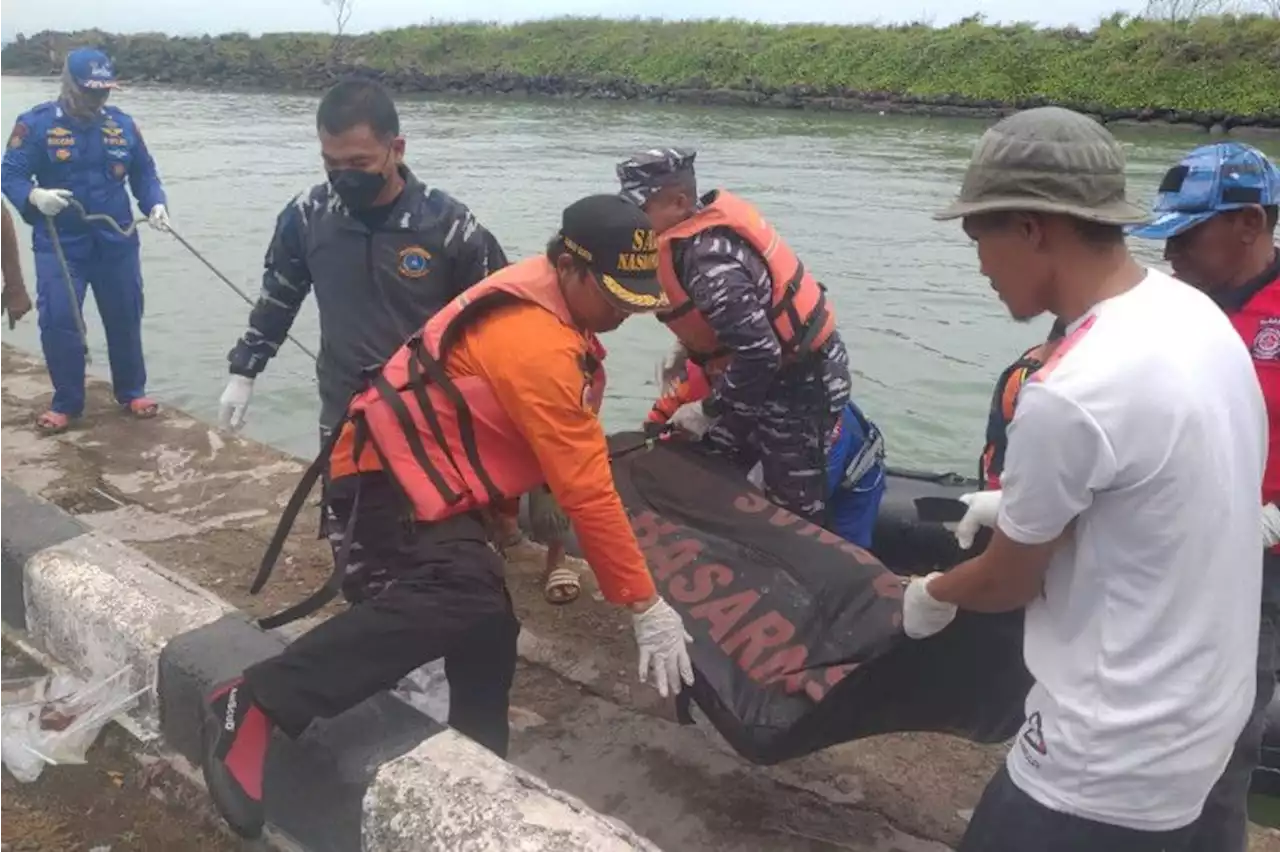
[{"x1": 617, "y1": 148, "x2": 850, "y2": 525}]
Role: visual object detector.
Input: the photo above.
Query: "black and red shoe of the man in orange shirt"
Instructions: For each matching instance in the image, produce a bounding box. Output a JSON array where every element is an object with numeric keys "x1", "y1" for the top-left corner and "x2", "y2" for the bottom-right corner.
[{"x1": 201, "y1": 678, "x2": 271, "y2": 840}]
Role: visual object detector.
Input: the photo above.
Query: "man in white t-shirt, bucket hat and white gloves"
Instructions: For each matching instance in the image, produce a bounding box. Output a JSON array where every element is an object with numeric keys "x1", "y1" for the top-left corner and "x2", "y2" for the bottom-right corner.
[{"x1": 904, "y1": 107, "x2": 1267, "y2": 852}]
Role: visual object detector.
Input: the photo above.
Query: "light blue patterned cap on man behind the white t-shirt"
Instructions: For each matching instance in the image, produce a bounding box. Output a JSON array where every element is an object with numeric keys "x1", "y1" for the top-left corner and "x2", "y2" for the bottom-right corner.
[{"x1": 1129, "y1": 142, "x2": 1280, "y2": 239}]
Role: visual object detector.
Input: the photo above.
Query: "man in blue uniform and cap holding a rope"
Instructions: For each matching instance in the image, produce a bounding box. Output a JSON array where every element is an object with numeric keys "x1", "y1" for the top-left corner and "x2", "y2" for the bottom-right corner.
[{"x1": 0, "y1": 47, "x2": 169, "y2": 432}]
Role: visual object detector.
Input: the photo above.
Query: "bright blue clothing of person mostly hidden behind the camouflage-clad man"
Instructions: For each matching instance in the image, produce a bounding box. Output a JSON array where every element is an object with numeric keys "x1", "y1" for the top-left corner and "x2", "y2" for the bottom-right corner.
[{"x1": 827, "y1": 402, "x2": 884, "y2": 550}]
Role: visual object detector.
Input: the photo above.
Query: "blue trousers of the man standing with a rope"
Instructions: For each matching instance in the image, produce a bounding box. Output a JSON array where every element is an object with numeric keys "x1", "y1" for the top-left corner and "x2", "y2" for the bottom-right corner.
[{"x1": 36, "y1": 243, "x2": 147, "y2": 417}]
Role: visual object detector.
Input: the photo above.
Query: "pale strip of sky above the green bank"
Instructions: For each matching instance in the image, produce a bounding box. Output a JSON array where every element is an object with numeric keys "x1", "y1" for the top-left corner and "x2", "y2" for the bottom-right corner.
[{"x1": 0, "y1": 0, "x2": 1162, "y2": 37}]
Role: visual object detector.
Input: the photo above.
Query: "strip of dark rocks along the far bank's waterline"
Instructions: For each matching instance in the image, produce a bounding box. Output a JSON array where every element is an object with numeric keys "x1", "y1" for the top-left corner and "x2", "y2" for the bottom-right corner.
[{"x1": 8, "y1": 59, "x2": 1280, "y2": 136}]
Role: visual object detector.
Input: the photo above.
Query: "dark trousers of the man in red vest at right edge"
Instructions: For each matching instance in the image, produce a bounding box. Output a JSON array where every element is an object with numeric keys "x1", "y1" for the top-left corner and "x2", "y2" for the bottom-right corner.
[{"x1": 1187, "y1": 603, "x2": 1280, "y2": 852}]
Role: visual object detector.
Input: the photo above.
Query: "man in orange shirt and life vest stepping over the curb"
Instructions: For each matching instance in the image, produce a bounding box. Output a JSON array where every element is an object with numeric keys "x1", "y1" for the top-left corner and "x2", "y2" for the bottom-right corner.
[{"x1": 204, "y1": 194, "x2": 694, "y2": 837}]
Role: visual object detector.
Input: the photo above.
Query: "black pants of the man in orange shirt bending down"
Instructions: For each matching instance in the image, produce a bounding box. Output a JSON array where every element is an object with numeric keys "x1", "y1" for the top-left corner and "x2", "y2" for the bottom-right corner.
[{"x1": 244, "y1": 475, "x2": 520, "y2": 757}]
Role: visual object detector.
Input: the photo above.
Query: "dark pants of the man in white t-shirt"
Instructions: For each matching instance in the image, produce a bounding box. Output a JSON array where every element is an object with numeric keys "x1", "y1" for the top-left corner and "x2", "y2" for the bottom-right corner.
[{"x1": 956, "y1": 766, "x2": 1190, "y2": 852}]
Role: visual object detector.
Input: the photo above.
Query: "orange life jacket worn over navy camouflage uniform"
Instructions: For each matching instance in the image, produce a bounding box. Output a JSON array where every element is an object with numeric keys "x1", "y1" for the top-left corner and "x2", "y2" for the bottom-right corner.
[{"x1": 658, "y1": 191, "x2": 836, "y2": 367}]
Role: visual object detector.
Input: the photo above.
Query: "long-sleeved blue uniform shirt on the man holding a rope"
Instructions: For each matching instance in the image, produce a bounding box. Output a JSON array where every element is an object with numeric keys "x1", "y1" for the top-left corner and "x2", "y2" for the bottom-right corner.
[{"x1": 0, "y1": 101, "x2": 165, "y2": 252}]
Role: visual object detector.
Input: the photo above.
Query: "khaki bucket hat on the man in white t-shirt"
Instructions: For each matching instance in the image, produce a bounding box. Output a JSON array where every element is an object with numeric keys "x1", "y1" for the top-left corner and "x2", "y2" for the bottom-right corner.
[{"x1": 933, "y1": 106, "x2": 1149, "y2": 225}]
